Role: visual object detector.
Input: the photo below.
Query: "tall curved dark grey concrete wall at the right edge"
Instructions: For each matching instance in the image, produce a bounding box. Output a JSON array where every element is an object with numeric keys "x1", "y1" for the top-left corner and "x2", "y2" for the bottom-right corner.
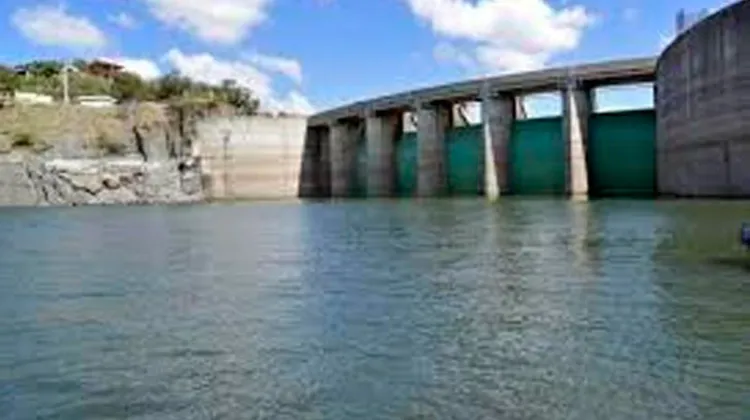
[{"x1": 656, "y1": 1, "x2": 750, "y2": 197}]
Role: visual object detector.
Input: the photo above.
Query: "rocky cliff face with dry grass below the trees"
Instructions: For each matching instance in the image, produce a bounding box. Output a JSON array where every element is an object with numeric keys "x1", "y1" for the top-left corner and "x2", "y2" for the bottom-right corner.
[{"x1": 0, "y1": 102, "x2": 205, "y2": 206}]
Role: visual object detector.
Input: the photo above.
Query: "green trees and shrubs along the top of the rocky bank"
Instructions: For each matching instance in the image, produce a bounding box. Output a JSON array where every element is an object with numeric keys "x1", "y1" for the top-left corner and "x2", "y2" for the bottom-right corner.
[{"x1": 0, "y1": 60, "x2": 259, "y2": 115}]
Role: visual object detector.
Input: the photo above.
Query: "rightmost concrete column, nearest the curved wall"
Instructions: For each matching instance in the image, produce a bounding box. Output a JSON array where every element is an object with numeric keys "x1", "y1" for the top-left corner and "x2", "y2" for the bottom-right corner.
[{"x1": 561, "y1": 83, "x2": 592, "y2": 200}]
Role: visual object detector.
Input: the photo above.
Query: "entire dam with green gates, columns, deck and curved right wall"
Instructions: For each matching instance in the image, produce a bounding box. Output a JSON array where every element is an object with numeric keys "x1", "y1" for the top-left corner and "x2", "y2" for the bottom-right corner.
[{"x1": 298, "y1": 1, "x2": 750, "y2": 199}]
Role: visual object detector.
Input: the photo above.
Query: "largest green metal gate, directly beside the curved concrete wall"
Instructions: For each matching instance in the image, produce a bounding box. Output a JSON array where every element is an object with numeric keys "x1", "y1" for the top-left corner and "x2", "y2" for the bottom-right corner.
[{"x1": 588, "y1": 109, "x2": 656, "y2": 197}]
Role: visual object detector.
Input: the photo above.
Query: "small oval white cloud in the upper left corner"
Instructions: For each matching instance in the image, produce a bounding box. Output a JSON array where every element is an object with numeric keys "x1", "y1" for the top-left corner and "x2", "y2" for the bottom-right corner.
[{"x1": 11, "y1": 5, "x2": 107, "y2": 49}]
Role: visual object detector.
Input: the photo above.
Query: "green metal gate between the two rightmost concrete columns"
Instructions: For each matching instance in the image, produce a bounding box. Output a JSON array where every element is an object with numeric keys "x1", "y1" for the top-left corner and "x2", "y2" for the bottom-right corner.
[{"x1": 508, "y1": 117, "x2": 566, "y2": 195}]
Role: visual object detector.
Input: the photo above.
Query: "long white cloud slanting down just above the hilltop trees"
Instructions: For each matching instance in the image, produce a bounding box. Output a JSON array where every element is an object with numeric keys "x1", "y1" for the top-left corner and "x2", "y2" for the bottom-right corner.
[{"x1": 164, "y1": 49, "x2": 314, "y2": 114}]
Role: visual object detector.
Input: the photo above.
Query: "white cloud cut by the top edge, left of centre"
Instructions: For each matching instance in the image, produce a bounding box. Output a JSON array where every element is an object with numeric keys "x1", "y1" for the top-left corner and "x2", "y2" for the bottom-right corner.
[{"x1": 143, "y1": 0, "x2": 272, "y2": 44}]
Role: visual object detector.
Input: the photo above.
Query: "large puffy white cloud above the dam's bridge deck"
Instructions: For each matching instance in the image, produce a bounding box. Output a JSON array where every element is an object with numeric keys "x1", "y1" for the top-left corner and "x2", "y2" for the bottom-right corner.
[{"x1": 406, "y1": 0, "x2": 593, "y2": 71}]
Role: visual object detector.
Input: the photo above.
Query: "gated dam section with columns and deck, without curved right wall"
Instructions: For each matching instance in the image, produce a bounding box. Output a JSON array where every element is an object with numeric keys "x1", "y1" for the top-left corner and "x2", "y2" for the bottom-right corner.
[{"x1": 301, "y1": 58, "x2": 656, "y2": 197}]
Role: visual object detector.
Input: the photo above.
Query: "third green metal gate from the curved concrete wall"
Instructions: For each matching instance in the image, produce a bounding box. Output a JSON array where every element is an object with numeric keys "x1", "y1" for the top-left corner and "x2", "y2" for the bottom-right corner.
[{"x1": 445, "y1": 125, "x2": 484, "y2": 196}]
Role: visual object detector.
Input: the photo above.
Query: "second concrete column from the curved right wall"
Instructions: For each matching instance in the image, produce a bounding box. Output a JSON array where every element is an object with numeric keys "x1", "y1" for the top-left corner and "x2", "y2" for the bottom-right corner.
[{"x1": 482, "y1": 95, "x2": 517, "y2": 200}]
